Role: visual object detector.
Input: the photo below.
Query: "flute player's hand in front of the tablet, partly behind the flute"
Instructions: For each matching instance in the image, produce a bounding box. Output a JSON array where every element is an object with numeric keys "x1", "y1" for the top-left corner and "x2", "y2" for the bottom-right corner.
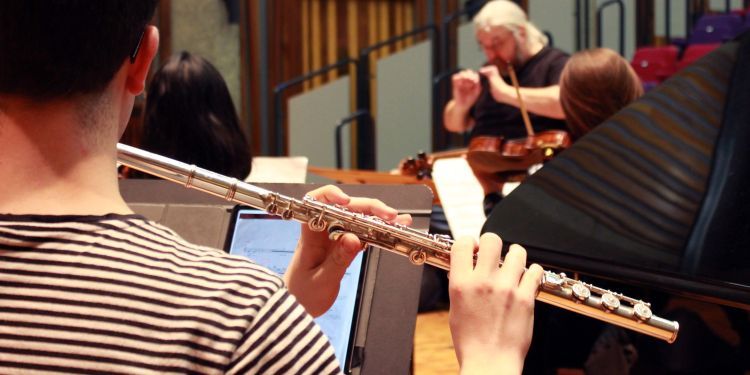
[{"x1": 284, "y1": 185, "x2": 411, "y2": 317}]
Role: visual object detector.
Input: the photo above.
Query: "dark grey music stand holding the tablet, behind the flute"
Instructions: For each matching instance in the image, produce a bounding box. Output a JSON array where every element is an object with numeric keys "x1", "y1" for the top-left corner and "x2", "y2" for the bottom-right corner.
[{"x1": 120, "y1": 180, "x2": 433, "y2": 374}]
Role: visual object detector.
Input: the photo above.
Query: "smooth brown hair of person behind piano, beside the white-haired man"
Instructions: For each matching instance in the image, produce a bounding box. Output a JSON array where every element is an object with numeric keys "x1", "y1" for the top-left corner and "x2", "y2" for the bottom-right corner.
[{"x1": 560, "y1": 48, "x2": 643, "y2": 140}]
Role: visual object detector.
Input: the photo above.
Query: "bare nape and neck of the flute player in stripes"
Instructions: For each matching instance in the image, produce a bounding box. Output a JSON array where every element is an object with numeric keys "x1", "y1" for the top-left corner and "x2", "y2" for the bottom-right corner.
[{"x1": 0, "y1": 97, "x2": 131, "y2": 215}]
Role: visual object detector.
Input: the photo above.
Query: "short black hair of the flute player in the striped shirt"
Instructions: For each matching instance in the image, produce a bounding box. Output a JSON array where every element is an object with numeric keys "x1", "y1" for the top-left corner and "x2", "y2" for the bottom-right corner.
[{"x1": 0, "y1": 0, "x2": 158, "y2": 100}]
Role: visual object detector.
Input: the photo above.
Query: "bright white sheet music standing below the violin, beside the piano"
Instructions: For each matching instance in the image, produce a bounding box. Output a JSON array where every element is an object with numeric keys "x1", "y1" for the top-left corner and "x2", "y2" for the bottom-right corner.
[{"x1": 432, "y1": 157, "x2": 486, "y2": 239}]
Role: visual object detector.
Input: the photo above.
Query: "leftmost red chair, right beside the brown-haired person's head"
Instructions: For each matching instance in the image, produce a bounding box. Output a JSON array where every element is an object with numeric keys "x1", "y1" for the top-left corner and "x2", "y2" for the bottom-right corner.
[{"x1": 630, "y1": 46, "x2": 679, "y2": 84}]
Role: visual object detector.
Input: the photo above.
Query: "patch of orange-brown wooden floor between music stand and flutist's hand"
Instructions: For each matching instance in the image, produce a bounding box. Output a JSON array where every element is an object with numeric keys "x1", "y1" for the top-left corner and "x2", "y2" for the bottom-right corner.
[{"x1": 414, "y1": 311, "x2": 458, "y2": 375}]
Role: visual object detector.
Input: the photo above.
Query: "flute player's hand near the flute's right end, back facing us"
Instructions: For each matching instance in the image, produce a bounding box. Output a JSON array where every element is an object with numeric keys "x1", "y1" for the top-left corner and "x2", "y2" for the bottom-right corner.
[{"x1": 449, "y1": 233, "x2": 543, "y2": 374}]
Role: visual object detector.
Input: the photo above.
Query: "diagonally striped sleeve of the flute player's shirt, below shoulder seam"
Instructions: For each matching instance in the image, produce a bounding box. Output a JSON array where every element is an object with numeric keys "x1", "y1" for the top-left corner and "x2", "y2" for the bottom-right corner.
[{"x1": 226, "y1": 288, "x2": 341, "y2": 374}]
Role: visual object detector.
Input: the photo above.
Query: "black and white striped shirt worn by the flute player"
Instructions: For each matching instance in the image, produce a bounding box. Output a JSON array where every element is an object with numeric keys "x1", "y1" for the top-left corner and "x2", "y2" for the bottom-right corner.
[{"x1": 0, "y1": 214, "x2": 340, "y2": 374}]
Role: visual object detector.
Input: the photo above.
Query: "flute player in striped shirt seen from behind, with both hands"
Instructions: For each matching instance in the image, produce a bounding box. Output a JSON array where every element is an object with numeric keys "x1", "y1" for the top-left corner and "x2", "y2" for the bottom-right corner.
[{"x1": 0, "y1": 0, "x2": 542, "y2": 374}]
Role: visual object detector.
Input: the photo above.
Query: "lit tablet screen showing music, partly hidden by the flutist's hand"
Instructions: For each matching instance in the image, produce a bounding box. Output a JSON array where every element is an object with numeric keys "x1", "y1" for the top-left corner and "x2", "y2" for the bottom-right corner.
[{"x1": 224, "y1": 206, "x2": 364, "y2": 372}]
